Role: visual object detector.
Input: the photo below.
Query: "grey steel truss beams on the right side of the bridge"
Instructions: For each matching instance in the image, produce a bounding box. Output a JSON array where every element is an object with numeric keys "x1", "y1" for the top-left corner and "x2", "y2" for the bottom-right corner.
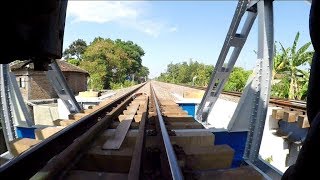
[{"x1": 196, "y1": 0, "x2": 310, "y2": 179}]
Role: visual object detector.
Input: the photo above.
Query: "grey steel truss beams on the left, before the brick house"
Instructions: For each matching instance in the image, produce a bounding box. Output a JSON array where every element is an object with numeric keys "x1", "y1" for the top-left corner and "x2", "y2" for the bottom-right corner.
[{"x1": 0, "y1": 60, "x2": 82, "y2": 149}]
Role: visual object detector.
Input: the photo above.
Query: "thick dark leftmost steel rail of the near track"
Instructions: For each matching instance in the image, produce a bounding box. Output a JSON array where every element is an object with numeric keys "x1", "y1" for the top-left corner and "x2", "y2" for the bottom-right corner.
[{"x1": 0, "y1": 83, "x2": 145, "y2": 179}]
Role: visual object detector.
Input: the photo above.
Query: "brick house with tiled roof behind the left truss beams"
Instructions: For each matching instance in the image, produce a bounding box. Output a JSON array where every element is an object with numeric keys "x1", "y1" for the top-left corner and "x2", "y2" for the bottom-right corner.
[{"x1": 10, "y1": 60, "x2": 89, "y2": 100}]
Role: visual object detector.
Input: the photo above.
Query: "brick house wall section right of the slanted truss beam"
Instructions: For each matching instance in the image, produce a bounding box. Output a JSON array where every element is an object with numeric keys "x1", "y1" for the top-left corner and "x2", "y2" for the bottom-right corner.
[{"x1": 63, "y1": 72, "x2": 87, "y2": 95}]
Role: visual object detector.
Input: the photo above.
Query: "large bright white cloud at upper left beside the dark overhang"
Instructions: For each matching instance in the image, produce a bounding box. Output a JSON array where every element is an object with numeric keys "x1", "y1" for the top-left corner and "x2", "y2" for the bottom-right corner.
[{"x1": 67, "y1": 1, "x2": 177, "y2": 37}]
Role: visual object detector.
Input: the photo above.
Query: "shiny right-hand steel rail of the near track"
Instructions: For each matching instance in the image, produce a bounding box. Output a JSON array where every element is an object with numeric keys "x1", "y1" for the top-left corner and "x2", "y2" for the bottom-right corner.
[{"x1": 152, "y1": 87, "x2": 184, "y2": 180}]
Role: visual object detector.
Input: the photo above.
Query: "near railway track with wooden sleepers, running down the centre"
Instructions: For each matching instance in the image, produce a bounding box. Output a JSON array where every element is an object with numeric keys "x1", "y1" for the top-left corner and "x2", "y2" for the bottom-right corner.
[{"x1": 0, "y1": 83, "x2": 262, "y2": 179}]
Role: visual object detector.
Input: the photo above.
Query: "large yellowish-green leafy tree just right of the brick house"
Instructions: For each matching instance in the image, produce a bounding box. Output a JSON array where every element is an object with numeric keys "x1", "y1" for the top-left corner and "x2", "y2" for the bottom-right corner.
[{"x1": 83, "y1": 37, "x2": 146, "y2": 88}]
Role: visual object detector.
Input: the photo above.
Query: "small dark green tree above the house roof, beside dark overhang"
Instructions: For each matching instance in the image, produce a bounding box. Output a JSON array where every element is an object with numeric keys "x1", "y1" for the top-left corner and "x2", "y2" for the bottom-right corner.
[{"x1": 63, "y1": 39, "x2": 87, "y2": 60}]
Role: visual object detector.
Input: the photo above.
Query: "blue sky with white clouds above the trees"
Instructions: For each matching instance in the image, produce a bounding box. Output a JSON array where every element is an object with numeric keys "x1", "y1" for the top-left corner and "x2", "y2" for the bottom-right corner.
[{"x1": 63, "y1": 0, "x2": 310, "y2": 78}]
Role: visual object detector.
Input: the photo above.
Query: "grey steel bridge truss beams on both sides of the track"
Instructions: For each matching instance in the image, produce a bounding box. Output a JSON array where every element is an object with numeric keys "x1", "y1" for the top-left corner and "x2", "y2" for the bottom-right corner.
[{"x1": 0, "y1": 0, "x2": 312, "y2": 179}]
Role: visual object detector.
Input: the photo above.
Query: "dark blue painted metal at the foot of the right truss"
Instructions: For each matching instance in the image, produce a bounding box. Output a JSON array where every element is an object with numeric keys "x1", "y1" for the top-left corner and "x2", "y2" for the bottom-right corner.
[{"x1": 213, "y1": 131, "x2": 248, "y2": 167}]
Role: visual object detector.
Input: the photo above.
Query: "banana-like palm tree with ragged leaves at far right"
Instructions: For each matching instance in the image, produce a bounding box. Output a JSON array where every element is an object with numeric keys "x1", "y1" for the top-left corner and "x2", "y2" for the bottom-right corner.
[{"x1": 278, "y1": 32, "x2": 313, "y2": 99}]
